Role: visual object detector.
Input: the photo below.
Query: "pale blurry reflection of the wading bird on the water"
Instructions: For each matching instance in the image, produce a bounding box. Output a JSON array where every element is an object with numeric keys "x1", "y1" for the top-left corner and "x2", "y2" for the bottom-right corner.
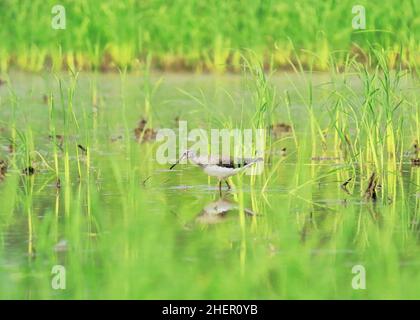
[{"x1": 196, "y1": 197, "x2": 256, "y2": 224}]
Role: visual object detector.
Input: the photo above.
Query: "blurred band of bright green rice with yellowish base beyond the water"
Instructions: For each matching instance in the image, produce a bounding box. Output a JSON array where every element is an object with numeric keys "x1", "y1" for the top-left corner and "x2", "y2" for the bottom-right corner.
[{"x1": 0, "y1": 0, "x2": 420, "y2": 72}]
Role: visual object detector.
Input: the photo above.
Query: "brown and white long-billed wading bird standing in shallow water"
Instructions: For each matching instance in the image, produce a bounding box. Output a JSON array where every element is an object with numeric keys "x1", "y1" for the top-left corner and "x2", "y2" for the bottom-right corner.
[{"x1": 169, "y1": 150, "x2": 264, "y2": 194}]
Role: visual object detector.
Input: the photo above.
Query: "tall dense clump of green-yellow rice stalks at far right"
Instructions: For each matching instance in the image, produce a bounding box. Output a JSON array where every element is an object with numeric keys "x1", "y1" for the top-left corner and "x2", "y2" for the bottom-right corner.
[{"x1": 326, "y1": 49, "x2": 407, "y2": 200}]
